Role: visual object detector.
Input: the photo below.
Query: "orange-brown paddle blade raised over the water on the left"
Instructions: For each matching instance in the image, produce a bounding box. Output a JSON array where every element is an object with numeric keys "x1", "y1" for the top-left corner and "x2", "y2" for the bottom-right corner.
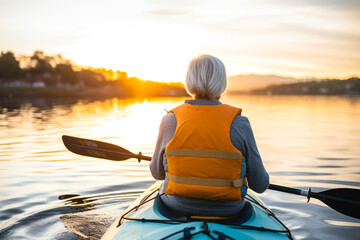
[{"x1": 62, "y1": 135, "x2": 137, "y2": 161}]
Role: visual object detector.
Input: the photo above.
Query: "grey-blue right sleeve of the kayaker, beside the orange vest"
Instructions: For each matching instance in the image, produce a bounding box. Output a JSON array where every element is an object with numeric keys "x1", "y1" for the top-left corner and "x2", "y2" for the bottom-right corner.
[{"x1": 230, "y1": 116, "x2": 269, "y2": 193}]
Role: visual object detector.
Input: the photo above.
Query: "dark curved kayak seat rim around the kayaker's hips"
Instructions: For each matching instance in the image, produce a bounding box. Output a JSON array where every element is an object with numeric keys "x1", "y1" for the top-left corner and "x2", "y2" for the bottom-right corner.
[{"x1": 154, "y1": 198, "x2": 254, "y2": 225}]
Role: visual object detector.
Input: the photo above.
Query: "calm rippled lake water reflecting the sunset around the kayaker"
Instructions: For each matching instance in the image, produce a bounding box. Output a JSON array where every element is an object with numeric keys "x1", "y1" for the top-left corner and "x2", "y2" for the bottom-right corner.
[{"x1": 0, "y1": 96, "x2": 360, "y2": 239}]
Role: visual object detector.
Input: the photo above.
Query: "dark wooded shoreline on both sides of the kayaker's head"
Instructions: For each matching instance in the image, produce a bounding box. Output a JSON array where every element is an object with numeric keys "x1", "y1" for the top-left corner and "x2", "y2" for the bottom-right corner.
[{"x1": 0, "y1": 50, "x2": 360, "y2": 97}]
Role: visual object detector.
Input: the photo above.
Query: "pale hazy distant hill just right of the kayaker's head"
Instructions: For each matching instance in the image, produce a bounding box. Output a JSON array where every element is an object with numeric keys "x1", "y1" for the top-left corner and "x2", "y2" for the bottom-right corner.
[{"x1": 228, "y1": 74, "x2": 300, "y2": 92}]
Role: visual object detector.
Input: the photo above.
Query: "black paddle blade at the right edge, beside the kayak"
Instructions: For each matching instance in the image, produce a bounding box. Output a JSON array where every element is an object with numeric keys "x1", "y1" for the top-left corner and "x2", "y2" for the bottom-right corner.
[{"x1": 311, "y1": 188, "x2": 360, "y2": 219}]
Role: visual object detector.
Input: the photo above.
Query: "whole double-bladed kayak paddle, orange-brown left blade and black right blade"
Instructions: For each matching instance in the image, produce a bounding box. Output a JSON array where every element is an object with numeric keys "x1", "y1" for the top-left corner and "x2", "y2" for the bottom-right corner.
[{"x1": 62, "y1": 135, "x2": 360, "y2": 219}]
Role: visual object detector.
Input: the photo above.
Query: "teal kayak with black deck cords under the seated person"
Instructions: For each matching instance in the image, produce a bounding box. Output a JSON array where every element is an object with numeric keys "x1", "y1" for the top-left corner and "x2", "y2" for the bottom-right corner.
[{"x1": 101, "y1": 182, "x2": 294, "y2": 240}]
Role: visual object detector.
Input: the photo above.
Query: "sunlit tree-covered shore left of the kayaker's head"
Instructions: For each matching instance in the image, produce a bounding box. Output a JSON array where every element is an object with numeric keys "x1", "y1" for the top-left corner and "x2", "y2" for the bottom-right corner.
[{"x1": 0, "y1": 50, "x2": 186, "y2": 97}]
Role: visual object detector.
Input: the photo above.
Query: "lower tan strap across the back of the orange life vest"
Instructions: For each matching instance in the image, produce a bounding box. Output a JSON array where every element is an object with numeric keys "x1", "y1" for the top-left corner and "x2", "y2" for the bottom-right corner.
[{"x1": 166, "y1": 173, "x2": 248, "y2": 188}]
